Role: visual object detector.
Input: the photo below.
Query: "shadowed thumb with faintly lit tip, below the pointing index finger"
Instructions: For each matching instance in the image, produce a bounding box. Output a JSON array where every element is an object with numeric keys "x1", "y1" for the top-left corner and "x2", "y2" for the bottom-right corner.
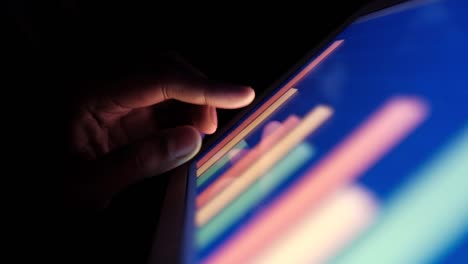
[{"x1": 68, "y1": 126, "x2": 201, "y2": 207}]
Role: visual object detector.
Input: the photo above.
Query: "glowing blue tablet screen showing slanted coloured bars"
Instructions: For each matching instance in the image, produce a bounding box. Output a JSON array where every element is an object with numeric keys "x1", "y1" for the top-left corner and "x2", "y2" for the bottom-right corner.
[{"x1": 195, "y1": 0, "x2": 468, "y2": 263}]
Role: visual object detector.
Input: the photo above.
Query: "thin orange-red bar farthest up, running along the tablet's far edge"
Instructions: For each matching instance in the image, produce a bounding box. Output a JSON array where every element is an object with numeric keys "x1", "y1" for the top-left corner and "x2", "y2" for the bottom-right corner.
[{"x1": 197, "y1": 40, "x2": 343, "y2": 168}]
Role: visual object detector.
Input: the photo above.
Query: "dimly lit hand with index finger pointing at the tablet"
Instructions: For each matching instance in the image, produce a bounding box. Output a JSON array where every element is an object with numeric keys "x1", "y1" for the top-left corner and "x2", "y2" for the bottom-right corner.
[{"x1": 66, "y1": 53, "x2": 255, "y2": 207}]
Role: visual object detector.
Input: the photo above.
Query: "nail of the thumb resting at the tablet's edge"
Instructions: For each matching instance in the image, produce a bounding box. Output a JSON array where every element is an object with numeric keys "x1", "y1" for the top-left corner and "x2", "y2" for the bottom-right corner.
[{"x1": 168, "y1": 126, "x2": 201, "y2": 159}]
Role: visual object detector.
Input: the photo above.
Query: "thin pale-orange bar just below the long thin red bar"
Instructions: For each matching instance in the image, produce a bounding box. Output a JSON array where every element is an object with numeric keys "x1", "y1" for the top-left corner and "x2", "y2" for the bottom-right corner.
[{"x1": 197, "y1": 88, "x2": 297, "y2": 175}]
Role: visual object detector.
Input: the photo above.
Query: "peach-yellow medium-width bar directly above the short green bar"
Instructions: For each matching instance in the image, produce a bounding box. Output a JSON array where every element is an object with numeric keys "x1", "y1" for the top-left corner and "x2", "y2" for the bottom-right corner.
[{"x1": 196, "y1": 105, "x2": 333, "y2": 226}]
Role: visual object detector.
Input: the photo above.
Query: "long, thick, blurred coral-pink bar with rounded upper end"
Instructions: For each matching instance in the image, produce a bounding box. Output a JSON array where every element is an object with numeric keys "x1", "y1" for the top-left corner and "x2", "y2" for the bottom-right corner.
[{"x1": 206, "y1": 97, "x2": 427, "y2": 263}]
